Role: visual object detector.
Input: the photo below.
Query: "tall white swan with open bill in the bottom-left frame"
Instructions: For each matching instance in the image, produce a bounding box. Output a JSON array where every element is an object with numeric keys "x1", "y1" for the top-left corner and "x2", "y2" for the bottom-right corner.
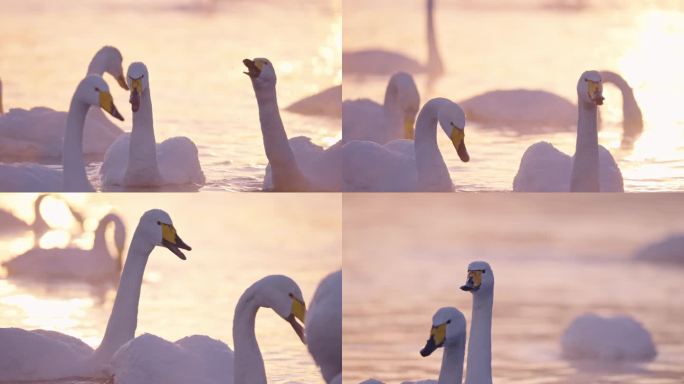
[{"x1": 0, "y1": 209, "x2": 190, "y2": 381}]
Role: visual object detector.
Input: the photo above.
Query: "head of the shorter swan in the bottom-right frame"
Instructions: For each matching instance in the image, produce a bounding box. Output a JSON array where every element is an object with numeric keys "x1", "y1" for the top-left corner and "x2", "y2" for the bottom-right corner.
[{"x1": 420, "y1": 307, "x2": 466, "y2": 357}]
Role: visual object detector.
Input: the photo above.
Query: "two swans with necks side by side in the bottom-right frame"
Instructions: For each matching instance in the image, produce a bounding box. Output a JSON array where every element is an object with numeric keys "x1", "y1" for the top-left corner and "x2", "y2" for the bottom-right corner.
[{"x1": 363, "y1": 261, "x2": 494, "y2": 384}]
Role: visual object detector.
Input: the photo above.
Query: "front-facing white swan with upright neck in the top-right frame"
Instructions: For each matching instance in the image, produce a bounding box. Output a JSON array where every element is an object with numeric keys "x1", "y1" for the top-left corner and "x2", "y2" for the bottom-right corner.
[{"x1": 513, "y1": 71, "x2": 624, "y2": 192}]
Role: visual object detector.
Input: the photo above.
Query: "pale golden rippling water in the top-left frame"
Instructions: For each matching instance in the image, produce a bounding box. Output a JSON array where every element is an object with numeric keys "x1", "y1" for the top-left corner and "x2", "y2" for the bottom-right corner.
[{"x1": 0, "y1": 0, "x2": 342, "y2": 191}]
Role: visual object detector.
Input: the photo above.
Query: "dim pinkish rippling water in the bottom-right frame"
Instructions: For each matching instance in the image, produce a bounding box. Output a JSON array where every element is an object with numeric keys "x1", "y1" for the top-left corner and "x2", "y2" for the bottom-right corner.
[{"x1": 343, "y1": 194, "x2": 684, "y2": 384}]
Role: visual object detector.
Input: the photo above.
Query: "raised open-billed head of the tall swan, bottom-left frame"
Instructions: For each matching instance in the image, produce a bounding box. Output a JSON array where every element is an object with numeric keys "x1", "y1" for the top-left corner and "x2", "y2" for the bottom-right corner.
[{"x1": 134, "y1": 209, "x2": 192, "y2": 260}]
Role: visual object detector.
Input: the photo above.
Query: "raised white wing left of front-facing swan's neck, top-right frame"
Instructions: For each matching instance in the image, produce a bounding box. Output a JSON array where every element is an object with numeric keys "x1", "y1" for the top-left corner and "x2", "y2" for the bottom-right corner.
[{"x1": 513, "y1": 142, "x2": 572, "y2": 192}]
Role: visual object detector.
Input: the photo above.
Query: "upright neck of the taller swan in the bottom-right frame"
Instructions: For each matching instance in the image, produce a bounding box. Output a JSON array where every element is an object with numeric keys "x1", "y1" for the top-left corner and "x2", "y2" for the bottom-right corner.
[{"x1": 465, "y1": 292, "x2": 494, "y2": 384}]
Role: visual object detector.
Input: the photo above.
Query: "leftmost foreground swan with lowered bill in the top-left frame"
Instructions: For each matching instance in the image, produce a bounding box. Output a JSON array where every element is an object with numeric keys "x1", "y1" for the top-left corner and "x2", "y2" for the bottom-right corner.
[{"x1": 0, "y1": 75, "x2": 123, "y2": 192}]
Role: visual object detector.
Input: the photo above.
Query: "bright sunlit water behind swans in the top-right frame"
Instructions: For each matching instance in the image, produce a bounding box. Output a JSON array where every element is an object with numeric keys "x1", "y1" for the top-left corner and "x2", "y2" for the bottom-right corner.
[{"x1": 343, "y1": 0, "x2": 684, "y2": 192}]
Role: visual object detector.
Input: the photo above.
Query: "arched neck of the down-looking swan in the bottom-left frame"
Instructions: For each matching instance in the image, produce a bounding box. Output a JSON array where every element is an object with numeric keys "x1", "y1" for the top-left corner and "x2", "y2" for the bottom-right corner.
[{"x1": 233, "y1": 289, "x2": 266, "y2": 384}]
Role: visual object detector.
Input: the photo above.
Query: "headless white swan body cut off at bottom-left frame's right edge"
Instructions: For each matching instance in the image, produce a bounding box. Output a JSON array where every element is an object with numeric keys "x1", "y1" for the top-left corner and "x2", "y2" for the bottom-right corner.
[{"x1": 305, "y1": 271, "x2": 342, "y2": 383}]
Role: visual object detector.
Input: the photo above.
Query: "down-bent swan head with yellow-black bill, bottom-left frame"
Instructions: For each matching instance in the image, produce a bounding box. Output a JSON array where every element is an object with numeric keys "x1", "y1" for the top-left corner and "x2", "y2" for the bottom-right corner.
[{"x1": 253, "y1": 275, "x2": 306, "y2": 344}]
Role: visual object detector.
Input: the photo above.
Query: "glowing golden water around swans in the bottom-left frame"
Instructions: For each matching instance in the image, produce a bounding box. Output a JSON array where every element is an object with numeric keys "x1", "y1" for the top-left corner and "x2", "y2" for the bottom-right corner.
[{"x1": 0, "y1": 194, "x2": 341, "y2": 383}]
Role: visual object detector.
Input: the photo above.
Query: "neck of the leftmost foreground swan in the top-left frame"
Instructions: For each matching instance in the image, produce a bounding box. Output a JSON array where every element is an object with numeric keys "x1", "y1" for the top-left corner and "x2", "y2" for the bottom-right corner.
[{"x1": 62, "y1": 95, "x2": 94, "y2": 192}]
